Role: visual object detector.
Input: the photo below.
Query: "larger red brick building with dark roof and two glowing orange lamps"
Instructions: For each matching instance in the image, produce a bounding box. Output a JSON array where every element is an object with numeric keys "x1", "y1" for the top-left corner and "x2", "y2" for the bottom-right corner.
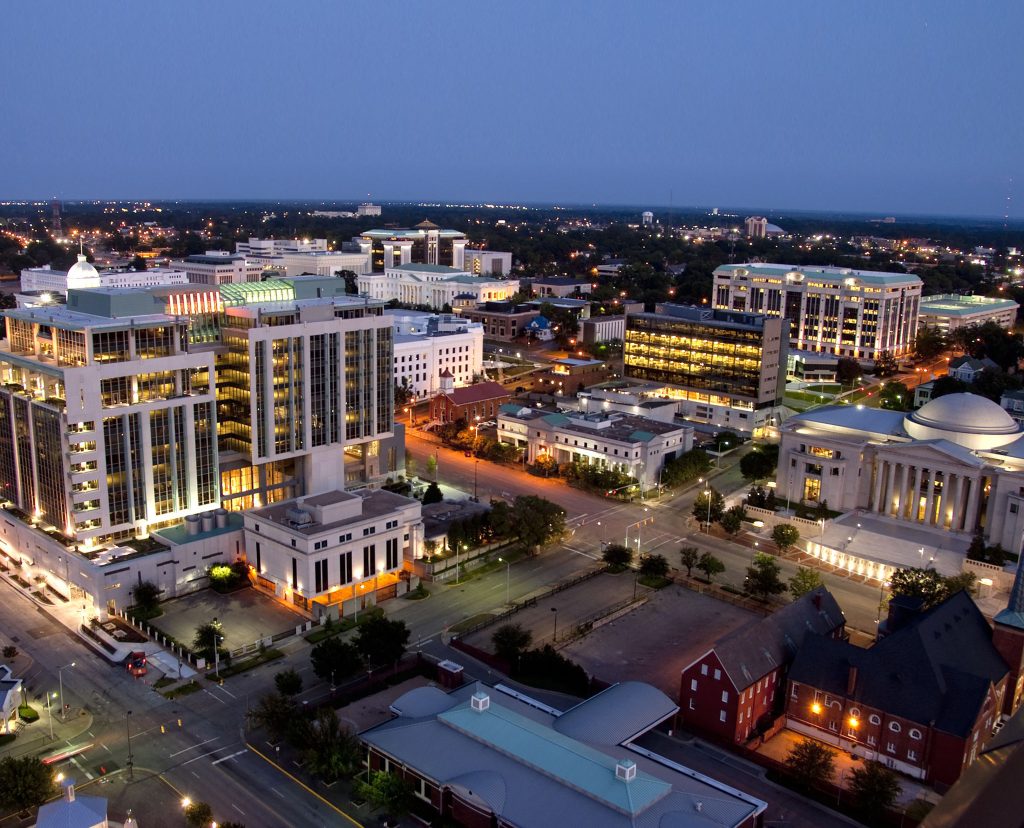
[{"x1": 785, "y1": 592, "x2": 1009, "y2": 787}]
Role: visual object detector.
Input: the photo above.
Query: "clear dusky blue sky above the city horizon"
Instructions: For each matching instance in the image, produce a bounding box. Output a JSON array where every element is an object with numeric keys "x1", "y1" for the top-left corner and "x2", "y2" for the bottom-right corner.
[{"x1": 0, "y1": 0, "x2": 1024, "y2": 218}]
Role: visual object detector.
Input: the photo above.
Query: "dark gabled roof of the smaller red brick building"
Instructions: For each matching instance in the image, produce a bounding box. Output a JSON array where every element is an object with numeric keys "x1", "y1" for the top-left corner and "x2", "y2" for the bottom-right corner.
[{"x1": 714, "y1": 586, "x2": 846, "y2": 691}]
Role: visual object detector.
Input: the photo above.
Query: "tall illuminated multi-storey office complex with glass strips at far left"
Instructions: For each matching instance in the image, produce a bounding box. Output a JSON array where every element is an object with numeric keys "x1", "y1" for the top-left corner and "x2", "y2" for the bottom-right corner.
[{"x1": 0, "y1": 276, "x2": 403, "y2": 611}]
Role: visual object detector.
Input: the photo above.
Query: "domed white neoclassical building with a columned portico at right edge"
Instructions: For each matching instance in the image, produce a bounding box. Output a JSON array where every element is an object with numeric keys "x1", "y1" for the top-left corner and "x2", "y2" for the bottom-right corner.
[{"x1": 776, "y1": 394, "x2": 1024, "y2": 553}]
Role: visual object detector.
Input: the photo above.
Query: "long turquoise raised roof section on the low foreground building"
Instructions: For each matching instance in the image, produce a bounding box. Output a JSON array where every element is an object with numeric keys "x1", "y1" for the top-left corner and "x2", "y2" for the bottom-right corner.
[{"x1": 437, "y1": 702, "x2": 672, "y2": 816}]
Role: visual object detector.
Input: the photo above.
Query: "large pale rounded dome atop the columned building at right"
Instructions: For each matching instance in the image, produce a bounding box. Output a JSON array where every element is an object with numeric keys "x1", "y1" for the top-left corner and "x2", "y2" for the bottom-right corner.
[{"x1": 903, "y1": 394, "x2": 1021, "y2": 450}]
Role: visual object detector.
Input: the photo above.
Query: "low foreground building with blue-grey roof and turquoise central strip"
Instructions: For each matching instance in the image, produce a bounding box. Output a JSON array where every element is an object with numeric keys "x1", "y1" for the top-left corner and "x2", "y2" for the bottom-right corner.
[{"x1": 359, "y1": 682, "x2": 767, "y2": 828}]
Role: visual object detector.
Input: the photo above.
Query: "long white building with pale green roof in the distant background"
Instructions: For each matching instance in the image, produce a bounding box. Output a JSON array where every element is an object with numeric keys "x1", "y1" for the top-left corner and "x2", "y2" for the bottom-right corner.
[{"x1": 356, "y1": 263, "x2": 518, "y2": 310}]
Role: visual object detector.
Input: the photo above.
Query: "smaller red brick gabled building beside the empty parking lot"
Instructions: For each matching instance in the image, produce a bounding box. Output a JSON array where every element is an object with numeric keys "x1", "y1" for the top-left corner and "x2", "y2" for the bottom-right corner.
[{"x1": 679, "y1": 586, "x2": 846, "y2": 744}]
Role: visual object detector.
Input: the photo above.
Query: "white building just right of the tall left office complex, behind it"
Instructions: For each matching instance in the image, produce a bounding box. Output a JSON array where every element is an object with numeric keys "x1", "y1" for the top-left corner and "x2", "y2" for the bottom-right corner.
[{"x1": 392, "y1": 311, "x2": 483, "y2": 399}]
